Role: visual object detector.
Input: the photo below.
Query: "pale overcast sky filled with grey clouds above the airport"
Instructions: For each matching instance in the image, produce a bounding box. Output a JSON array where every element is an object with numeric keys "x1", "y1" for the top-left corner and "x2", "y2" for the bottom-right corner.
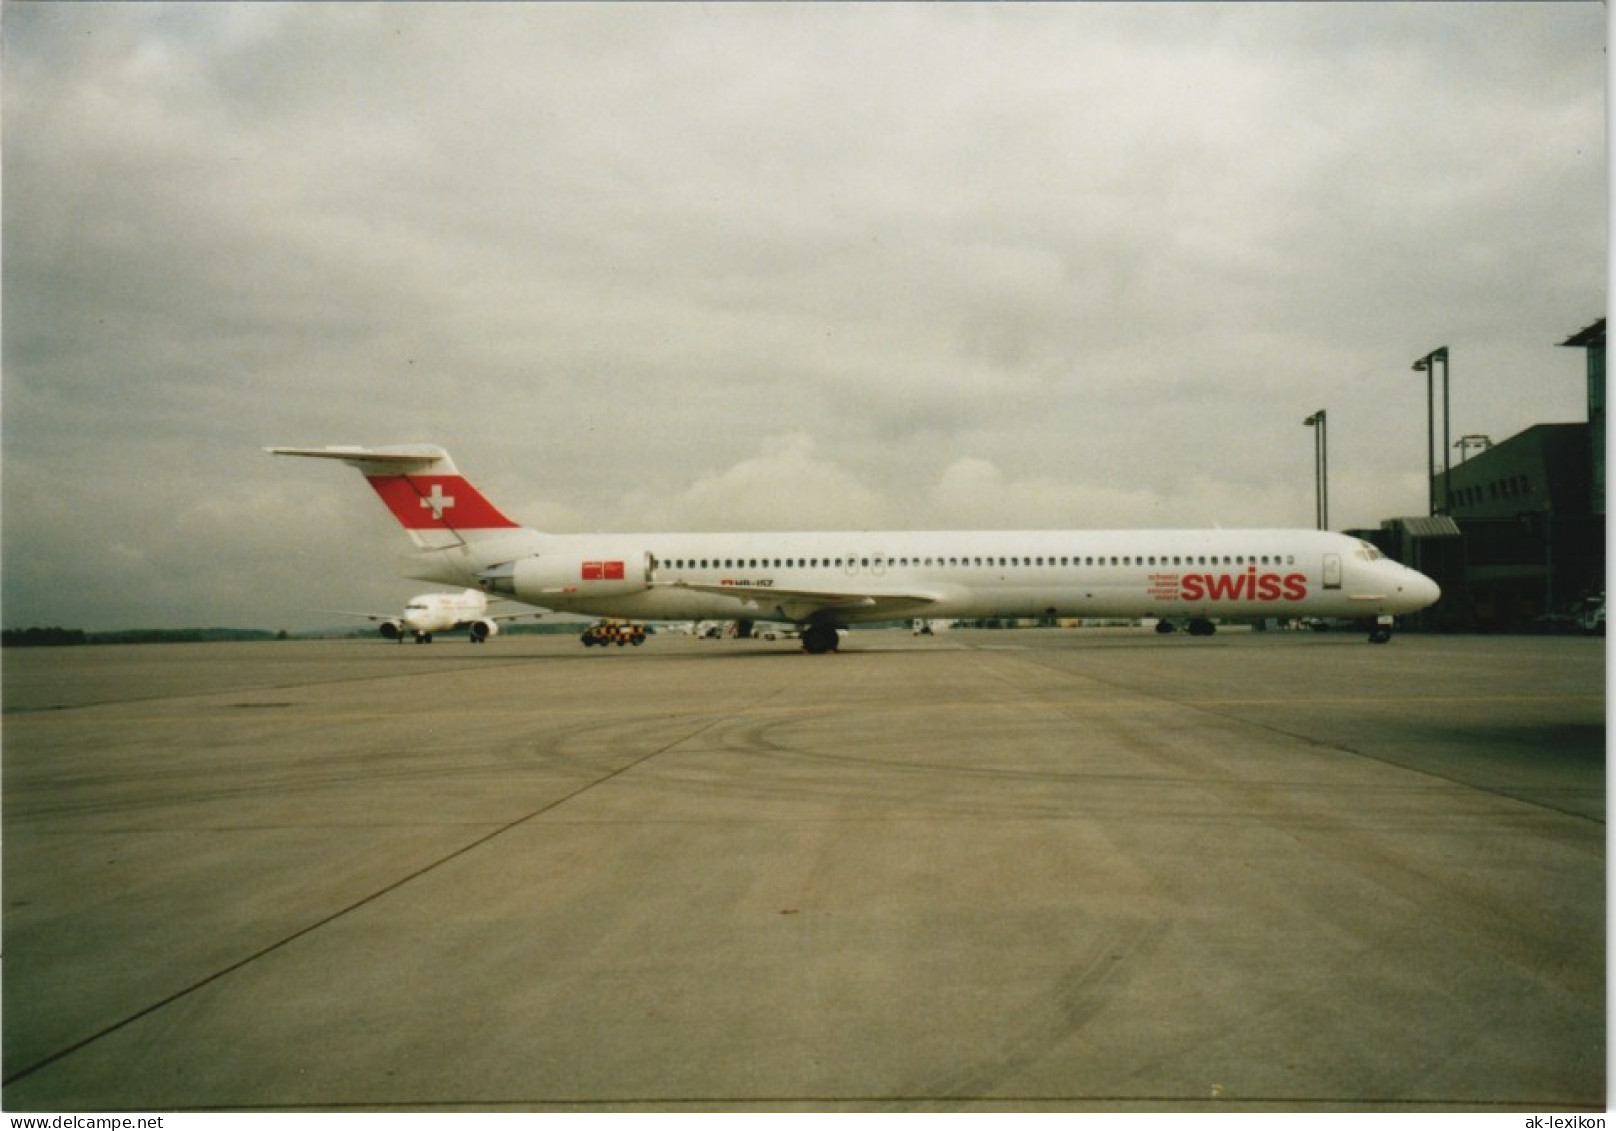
[{"x1": 3, "y1": 3, "x2": 1608, "y2": 629}]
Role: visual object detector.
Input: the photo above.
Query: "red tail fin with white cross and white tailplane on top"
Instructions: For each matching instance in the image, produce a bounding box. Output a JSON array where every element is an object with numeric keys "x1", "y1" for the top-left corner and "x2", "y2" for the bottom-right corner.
[{"x1": 263, "y1": 444, "x2": 519, "y2": 549}]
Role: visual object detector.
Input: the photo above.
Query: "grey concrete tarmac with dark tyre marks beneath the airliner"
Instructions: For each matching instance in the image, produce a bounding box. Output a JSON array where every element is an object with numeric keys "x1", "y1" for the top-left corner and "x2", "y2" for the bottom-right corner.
[{"x1": 0, "y1": 629, "x2": 1606, "y2": 1112}]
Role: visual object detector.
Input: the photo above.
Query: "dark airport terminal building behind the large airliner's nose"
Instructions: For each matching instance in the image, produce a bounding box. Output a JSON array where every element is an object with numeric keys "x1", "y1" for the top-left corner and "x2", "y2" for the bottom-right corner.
[{"x1": 1361, "y1": 318, "x2": 1605, "y2": 632}]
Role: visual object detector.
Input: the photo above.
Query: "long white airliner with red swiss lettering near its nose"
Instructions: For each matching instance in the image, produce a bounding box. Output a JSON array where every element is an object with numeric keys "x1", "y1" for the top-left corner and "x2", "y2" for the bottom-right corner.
[{"x1": 265, "y1": 444, "x2": 1441, "y2": 653}]
